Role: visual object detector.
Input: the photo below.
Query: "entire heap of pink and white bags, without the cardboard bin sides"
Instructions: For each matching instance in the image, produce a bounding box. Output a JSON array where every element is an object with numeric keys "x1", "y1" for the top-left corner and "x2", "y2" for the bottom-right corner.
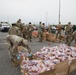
[{"x1": 21, "y1": 44, "x2": 76, "y2": 75}]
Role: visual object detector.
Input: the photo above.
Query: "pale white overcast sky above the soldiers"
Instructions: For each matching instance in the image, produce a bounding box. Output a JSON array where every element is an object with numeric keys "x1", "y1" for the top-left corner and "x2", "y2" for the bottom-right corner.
[{"x1": 0, "y1": 0, "x2": 76, "y2": 24}]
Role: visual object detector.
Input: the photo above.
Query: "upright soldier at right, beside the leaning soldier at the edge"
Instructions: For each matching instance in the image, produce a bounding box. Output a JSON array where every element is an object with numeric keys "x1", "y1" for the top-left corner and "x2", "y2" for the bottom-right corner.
[{"x1": 65, "y1": 22, "x2": 73, "y2": 44}]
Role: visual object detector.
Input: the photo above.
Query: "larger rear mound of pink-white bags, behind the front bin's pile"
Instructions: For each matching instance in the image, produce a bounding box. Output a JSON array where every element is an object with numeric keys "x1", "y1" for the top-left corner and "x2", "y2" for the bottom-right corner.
[{"x1": 35, "y1": 44, "x2": 76, "y2": 61}]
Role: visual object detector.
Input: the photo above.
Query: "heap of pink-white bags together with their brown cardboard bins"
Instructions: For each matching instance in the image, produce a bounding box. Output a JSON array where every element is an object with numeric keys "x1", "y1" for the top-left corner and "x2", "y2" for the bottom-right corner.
[{"x1": 20, "y1": 44, "x2": 76, "y2": 75}]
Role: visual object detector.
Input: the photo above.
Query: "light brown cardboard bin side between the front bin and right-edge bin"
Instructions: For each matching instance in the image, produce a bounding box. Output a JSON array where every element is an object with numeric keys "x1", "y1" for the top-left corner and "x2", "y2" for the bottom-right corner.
[{"x1": 54, "y1": 61, "x2": 69, "y2": 75}]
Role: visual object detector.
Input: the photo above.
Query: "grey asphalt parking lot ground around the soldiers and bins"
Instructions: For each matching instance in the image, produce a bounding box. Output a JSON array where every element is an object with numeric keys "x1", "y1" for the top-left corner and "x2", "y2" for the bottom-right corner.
[{"x1": 0, "y1": 32, "x2": 76, "y2": 75}]
